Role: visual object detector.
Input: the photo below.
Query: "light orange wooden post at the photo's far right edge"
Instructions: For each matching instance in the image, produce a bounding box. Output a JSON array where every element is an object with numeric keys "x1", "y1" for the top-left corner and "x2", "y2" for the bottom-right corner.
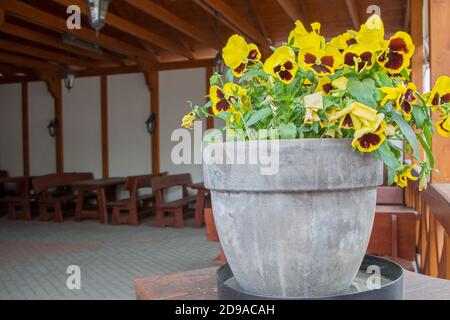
[{"x1": 429, "y1": 0, "x2": 450, "y2": 182}]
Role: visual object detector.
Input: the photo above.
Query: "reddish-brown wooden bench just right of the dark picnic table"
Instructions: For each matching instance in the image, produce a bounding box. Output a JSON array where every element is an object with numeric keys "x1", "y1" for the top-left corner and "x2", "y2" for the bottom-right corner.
[{"x1": 106, "y1": 172, "x2": 167, "y2": 226}]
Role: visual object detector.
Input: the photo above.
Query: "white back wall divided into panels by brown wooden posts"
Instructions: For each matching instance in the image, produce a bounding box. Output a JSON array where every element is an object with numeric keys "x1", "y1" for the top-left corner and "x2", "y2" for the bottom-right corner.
[{"x1": 0, "y1": 68, "x2": 206, "y2": 181}]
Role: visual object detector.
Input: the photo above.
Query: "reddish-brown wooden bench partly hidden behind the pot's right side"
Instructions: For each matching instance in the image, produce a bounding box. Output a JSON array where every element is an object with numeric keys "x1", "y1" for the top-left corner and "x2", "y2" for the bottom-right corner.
[{"x1": 367, "y1": 186, "x2": 420, "y2": 271}]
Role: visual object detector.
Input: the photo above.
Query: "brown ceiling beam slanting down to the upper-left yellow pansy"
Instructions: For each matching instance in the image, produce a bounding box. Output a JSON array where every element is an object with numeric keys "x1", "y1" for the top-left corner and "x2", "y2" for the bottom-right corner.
[{"x1": 195, "y1": 0, "x2": 270, "y2": 52}]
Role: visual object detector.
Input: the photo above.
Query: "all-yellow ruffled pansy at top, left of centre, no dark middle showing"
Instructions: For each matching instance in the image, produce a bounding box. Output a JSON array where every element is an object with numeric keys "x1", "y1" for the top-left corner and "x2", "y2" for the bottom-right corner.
[{"x1": 288, "y1": 20, "x2": 325, "y2": 49}]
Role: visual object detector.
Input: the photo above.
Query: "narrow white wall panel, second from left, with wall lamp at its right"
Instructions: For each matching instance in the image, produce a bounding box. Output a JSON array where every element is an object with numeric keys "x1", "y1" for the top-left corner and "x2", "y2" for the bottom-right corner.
[{"x1": 28, "y1": 82, "x2": 56, "y2": 175}]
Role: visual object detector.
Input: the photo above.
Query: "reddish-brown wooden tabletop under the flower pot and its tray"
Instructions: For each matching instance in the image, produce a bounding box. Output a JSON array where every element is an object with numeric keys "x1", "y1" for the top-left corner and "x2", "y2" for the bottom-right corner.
[{"x1": 135, "y1": 267, "x2": 450, "y2": 300}]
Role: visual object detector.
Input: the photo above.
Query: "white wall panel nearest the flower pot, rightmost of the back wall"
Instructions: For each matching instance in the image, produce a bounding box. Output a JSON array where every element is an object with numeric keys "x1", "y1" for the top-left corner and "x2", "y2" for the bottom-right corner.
[{"x1": 159, "y1": 68, "x2": 206, "y2": 182}]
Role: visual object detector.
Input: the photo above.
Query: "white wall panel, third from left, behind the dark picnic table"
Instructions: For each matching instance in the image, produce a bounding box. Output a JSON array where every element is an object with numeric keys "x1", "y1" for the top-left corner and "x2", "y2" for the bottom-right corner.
[{"x1": 63, "y1": 77, "x2": 102, "y2": 178}]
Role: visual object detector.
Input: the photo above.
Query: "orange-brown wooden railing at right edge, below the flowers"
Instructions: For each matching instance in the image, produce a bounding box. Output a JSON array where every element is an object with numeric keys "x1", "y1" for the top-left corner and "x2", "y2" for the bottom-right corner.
[{"x1": 406, "y1": 181, "x2": 450, "y2": 279}]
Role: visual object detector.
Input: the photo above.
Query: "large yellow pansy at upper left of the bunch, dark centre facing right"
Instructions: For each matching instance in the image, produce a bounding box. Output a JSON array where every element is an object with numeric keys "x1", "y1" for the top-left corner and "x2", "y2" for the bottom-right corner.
[{"x1": 222, "y1": 34, "x2": 261, "y2": 78}]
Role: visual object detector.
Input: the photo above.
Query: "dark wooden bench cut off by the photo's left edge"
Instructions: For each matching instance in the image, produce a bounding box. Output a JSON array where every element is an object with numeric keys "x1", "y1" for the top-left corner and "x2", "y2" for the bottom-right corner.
[{"x1": 0, "y1": 177, "x2": 32, "y2": 220}]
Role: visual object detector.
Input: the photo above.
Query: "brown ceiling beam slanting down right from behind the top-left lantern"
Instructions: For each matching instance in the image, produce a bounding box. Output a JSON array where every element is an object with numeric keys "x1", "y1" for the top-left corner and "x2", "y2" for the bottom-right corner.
[{"x1": 53, "y1": 0, "x2": 195, "y2": 59}]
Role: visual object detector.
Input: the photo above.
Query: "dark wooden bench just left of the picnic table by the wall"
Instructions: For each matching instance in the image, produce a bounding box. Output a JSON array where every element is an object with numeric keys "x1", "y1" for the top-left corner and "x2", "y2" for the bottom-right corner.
[{"x1": 32, "y1": 172, "x2": 93, "y2": 223}]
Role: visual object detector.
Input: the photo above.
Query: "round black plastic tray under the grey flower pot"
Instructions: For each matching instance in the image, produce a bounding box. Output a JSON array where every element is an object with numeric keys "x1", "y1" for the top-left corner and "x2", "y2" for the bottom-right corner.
[{"x1": 217, "y1": 255, "x2": 403, "y2": 300}]
